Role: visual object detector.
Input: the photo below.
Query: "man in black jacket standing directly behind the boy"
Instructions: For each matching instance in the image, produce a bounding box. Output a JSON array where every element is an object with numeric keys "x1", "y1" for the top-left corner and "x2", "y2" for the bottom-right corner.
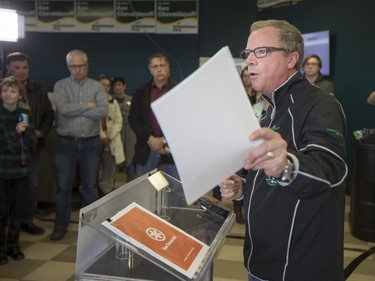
[{"x1": 6, "y1": 52, "x2": 55, "y2": 235}]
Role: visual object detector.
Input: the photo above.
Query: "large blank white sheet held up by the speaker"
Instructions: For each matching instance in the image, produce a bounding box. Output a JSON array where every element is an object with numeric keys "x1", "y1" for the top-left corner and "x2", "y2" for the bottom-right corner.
[{"x1": 151, "y1": 47, "x2": 260, "y2": 204}]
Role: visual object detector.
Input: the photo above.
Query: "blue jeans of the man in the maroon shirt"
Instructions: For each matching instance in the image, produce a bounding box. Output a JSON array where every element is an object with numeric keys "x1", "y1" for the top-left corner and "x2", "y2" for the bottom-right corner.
[{"x1": 136, "y1": 151, "x2": 186, "y2": 207}]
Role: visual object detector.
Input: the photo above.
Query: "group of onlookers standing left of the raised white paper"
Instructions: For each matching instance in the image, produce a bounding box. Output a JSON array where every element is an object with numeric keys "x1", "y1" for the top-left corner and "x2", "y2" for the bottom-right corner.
[{"x1": 0, "y1": 47, "x2": 186, "y2": 265}]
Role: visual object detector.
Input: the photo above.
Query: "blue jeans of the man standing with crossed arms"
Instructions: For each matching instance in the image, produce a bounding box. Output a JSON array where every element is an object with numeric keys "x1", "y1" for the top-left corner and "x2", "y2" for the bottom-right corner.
[{"x1": 54, "y1": 136, "x2": 101, "y2": 230}]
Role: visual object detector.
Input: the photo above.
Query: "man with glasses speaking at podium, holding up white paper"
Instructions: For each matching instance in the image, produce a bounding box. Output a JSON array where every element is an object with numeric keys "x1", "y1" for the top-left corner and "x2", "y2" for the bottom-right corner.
[{"x1": 220, "y1": 20, "x2": 348, "y2": 281}]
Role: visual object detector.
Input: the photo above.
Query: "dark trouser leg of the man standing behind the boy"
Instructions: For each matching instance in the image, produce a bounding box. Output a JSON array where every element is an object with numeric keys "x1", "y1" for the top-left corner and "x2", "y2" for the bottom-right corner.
[{"x1": 21, "y1": 151, "x2": 41, "y2": 223}]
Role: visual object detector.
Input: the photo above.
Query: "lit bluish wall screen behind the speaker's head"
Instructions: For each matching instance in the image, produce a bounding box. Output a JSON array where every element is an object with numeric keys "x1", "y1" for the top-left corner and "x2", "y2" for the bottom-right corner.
[{"x1": 302, "y1": 30, "x2": 330, "y2": 76}]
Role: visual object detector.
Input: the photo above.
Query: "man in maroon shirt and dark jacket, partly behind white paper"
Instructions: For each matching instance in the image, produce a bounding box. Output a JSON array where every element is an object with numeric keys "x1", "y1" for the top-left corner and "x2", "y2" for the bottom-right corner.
[{"x1": 129, "y1": 53, "x2": 184, "y2": 206}]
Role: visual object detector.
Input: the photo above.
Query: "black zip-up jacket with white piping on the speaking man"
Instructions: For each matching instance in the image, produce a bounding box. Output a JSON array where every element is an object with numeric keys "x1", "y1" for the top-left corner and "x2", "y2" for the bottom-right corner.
[{"x1": 244, "y1": 72, "x2": 347, "y2": 281}]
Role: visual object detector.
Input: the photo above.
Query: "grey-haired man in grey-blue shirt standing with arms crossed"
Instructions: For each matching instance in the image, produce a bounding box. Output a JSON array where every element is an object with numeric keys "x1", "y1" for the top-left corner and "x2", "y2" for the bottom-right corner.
[{"x1": 50, "y1": 50, "x2": 108, "y2": 241}]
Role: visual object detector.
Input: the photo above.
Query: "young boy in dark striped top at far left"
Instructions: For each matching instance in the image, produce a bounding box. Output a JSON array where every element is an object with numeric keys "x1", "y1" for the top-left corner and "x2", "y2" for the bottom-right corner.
[{"x1": 0, "y1": 76, "x2": 35, "y2": 265}]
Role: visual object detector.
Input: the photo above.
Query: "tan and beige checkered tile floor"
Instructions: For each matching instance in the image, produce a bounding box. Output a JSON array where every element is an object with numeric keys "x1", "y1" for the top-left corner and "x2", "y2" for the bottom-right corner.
[{"x1": 0, "y1": 173, "x2": 375, "y2": 281}]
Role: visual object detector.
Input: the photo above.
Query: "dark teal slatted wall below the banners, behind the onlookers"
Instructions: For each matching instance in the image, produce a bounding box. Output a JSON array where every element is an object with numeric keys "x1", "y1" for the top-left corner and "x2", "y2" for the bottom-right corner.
[{"x1": 4, "y1": 32, "x2": 198, "y2": 95}]
